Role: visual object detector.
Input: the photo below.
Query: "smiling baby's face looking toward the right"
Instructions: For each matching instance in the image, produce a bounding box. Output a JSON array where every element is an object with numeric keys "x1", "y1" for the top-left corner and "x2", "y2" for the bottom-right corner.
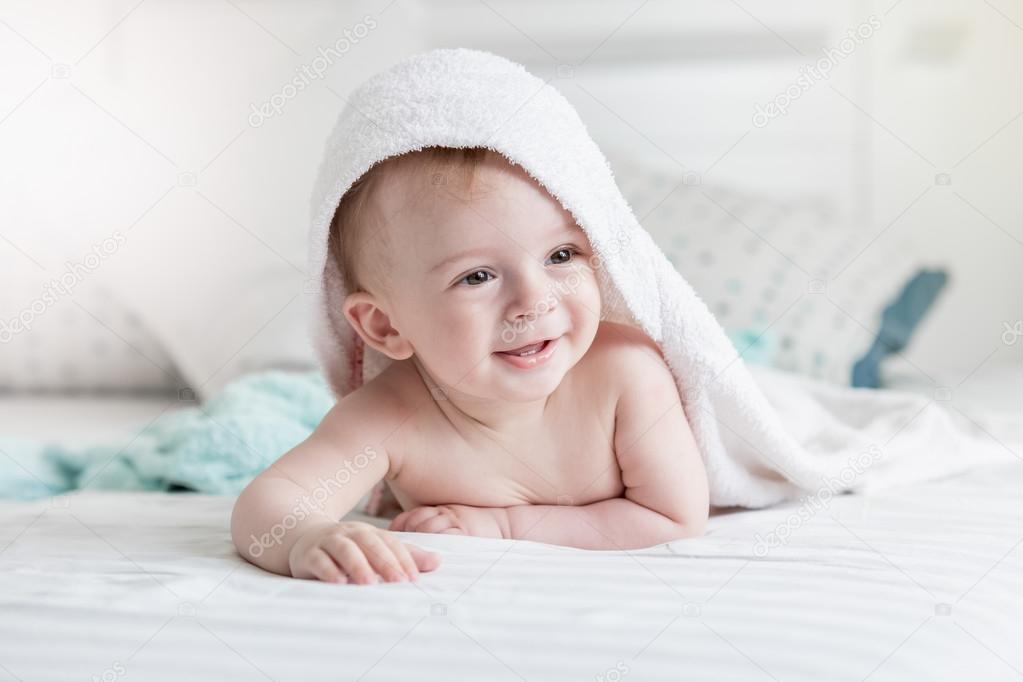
[{"x1": 372, "y1": 153, "x2": 601, "y2": 402}]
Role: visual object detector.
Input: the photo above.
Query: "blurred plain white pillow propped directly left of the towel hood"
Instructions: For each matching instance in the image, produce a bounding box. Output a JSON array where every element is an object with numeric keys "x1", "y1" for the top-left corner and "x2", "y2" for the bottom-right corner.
[{"x1": 94, "y1": 192, "x2": 316, "y2": 400}]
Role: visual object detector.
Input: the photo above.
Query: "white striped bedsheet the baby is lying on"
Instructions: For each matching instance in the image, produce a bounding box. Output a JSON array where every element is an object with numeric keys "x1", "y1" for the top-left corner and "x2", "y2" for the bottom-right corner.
[{"x1": 0, "y1": 369, "x2": 1023, "y2": 681}]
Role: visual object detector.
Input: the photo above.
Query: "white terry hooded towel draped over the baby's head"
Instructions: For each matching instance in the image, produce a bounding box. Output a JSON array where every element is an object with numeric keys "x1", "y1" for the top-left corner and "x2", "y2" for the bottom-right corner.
[{"x1": 309, "y1": 49, "x2": 1006, "y2": 507}]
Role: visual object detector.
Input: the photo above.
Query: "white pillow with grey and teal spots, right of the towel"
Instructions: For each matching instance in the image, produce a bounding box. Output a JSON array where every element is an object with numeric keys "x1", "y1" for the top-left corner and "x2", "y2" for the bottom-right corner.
[{"x1": 613, "y1": 158, "x2": 932, "y2": 385}]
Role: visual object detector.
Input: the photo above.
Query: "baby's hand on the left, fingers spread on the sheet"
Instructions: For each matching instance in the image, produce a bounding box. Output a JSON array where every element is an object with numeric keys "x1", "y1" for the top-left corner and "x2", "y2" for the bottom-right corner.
[{"x1": 288, "y1": 521, "x2": 440, "y2": 585}]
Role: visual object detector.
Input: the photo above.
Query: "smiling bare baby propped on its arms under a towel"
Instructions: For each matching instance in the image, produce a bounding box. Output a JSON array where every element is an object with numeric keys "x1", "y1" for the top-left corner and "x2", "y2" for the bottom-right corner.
[{"x1": 231, "y1": 147, "x2": 709, "y2": 584}]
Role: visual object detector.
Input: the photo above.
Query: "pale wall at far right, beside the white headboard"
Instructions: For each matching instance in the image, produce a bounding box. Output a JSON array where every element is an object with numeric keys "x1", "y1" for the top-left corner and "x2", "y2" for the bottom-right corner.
[{"x1": 865, "y1": 0, "x2": 1023, "y2": 378}]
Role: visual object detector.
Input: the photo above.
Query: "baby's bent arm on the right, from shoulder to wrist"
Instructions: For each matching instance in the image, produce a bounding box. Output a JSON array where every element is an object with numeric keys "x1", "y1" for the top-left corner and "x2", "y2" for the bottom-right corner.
[{"x1": 506, "y1": 340, "x2": 710, "y2": 549}]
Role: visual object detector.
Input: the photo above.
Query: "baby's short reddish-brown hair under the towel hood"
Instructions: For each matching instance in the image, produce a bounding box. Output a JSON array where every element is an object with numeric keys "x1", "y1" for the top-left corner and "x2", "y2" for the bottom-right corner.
[{"x1": 327, "y1": 146, "x2": 488, "y2": 293}]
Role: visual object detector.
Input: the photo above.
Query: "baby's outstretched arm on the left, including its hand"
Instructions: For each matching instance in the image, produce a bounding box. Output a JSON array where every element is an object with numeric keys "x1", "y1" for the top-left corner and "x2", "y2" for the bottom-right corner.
[{"x1": 231, "y1": 392, "x2": 438, "y2": 582}]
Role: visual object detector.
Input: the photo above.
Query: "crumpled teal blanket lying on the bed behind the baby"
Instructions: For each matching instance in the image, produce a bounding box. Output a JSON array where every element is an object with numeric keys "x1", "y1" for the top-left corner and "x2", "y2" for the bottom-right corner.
[{"x1": 0, "y1": 370, "x2": 336, "y2": 500}]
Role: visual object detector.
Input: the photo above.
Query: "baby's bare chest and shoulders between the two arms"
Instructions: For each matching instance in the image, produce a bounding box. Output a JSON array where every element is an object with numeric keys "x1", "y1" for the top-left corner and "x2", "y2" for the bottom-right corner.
[{"x1": 364, "y1": 322, "x2": 625, "y2": 509}]
